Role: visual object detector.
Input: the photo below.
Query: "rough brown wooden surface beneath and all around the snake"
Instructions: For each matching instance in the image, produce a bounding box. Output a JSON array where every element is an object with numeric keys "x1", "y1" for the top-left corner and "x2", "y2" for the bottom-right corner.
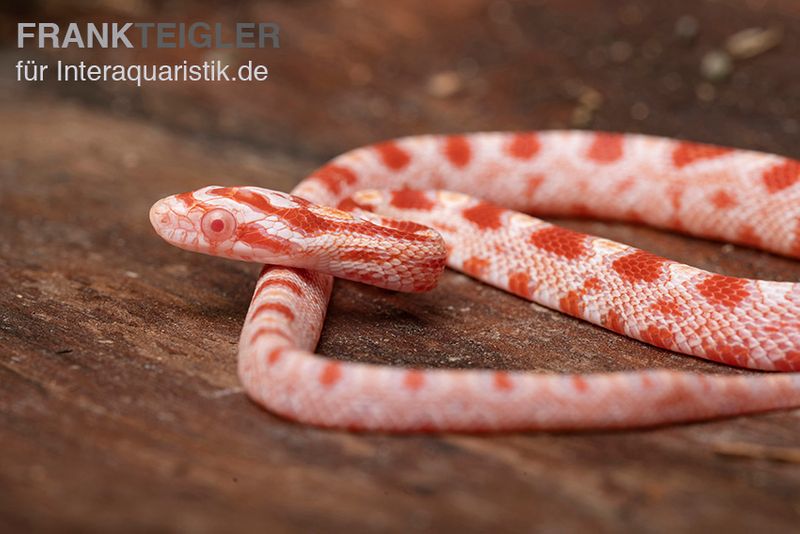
[{"x1": 0, "y1": 0, "x2": 800, "y2": 532}]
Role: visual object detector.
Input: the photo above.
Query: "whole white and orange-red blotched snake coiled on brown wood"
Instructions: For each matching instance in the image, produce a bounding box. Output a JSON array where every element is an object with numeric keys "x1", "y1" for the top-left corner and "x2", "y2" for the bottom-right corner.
[{"x1": 150, "y1": 130, "x2": 800, "y2": 433}]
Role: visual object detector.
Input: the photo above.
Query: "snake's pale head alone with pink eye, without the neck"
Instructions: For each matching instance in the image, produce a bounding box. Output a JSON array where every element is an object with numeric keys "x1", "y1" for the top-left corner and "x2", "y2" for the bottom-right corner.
[{"x1": 150, "y1": 185, "x2": 302, "y2": 265}]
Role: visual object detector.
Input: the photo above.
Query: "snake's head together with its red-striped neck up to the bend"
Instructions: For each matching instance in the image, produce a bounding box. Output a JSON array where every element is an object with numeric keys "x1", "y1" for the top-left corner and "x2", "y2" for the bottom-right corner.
[{"x1": 150, "y1": 186, "x2": 447, "y2": 291}]
